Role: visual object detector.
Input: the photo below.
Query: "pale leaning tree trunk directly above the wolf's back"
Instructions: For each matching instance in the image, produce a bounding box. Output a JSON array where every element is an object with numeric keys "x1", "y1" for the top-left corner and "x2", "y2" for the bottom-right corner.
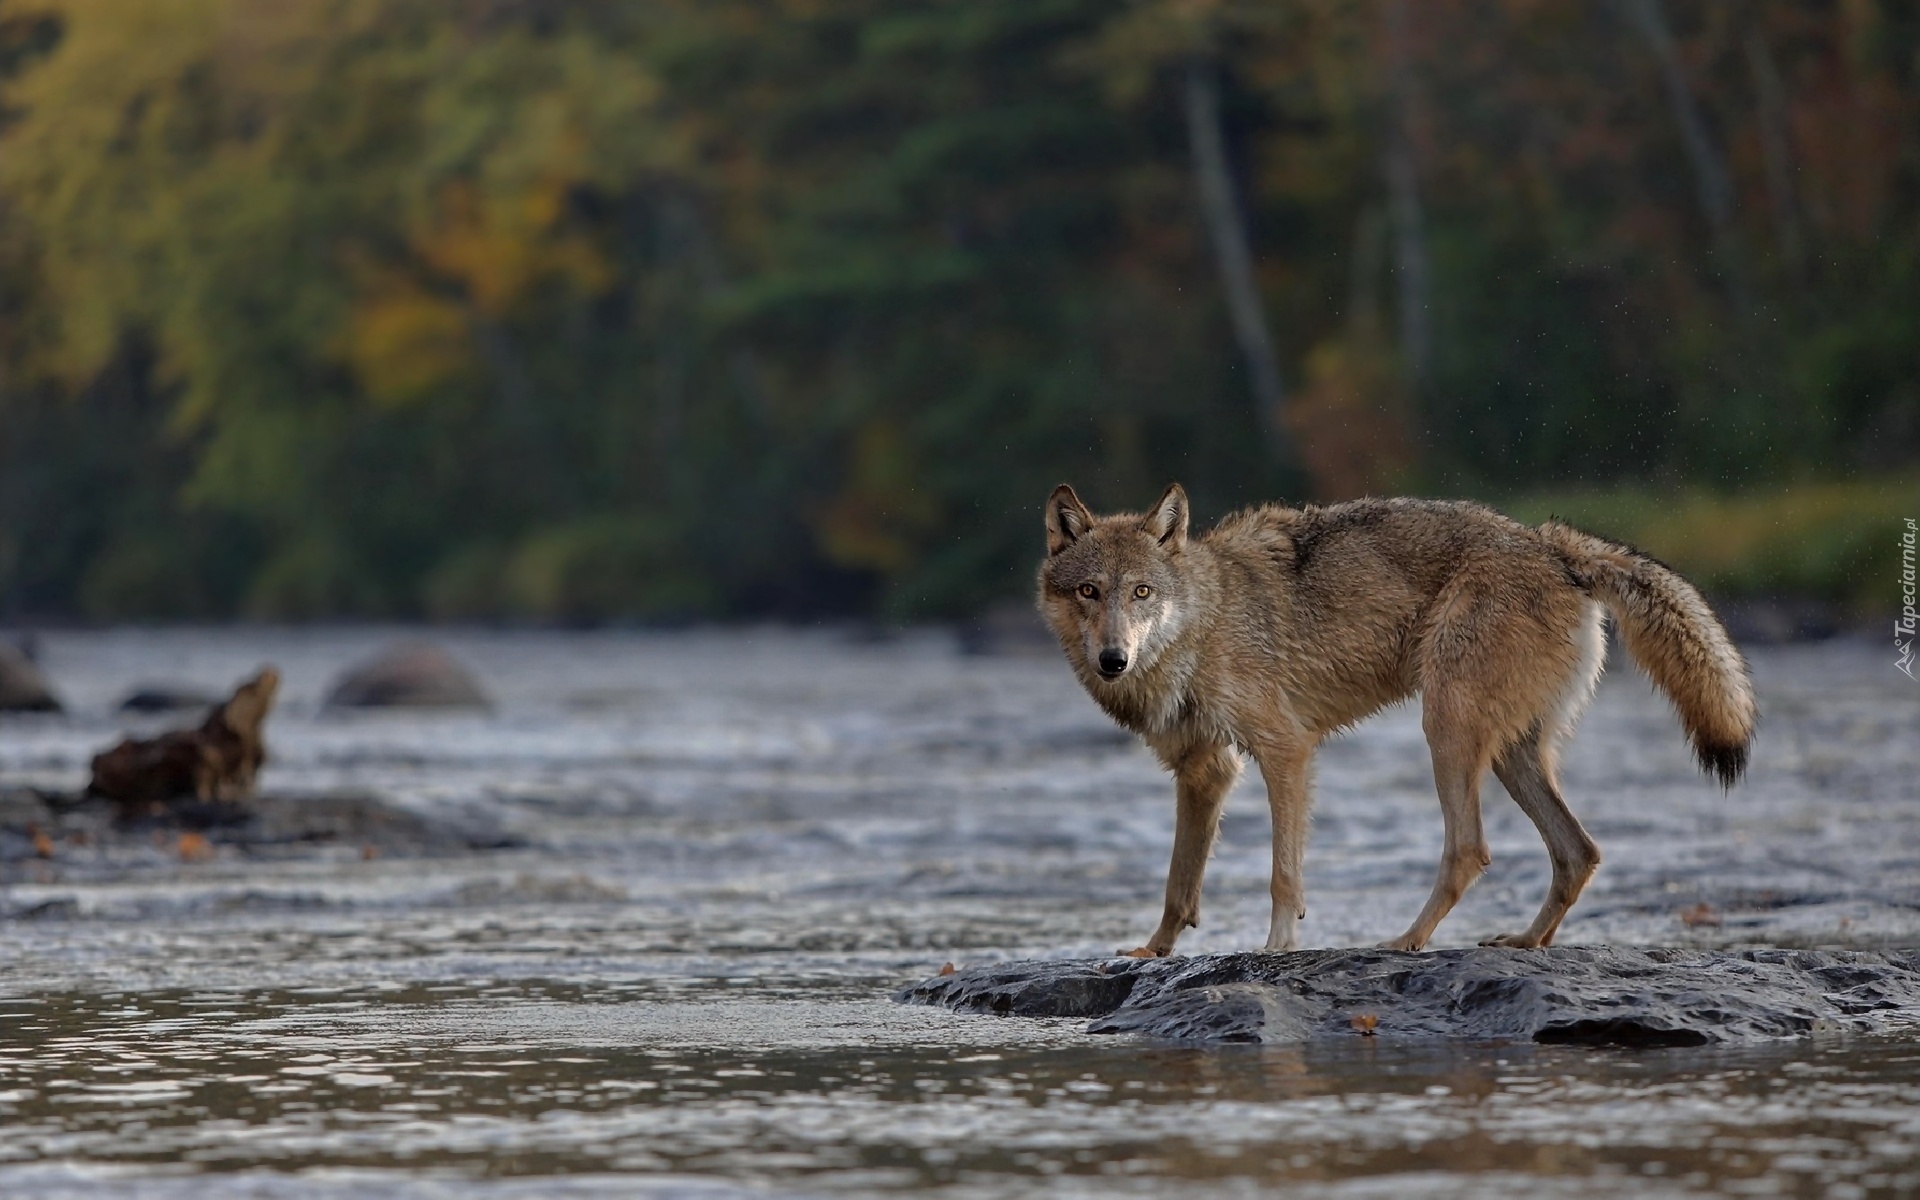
[{"x1": 1183, "y1": 61, "x2": 1292, "y2": 461}]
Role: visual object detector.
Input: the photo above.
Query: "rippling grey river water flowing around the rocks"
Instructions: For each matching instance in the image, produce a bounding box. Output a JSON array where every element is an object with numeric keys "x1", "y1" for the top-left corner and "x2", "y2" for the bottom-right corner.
[{"x1": 0, "y1": 628, "x2": 1920, "y2": 1200}]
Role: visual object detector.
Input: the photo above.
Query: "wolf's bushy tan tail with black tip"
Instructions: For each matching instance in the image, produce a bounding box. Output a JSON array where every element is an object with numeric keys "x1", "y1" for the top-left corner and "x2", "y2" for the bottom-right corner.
[{"x1": 1540, "y1": 520, "x2": 1757, "y2": 787}]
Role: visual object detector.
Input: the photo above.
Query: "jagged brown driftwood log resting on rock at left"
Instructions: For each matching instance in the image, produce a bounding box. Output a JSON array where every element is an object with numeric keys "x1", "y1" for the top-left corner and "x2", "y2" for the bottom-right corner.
[{"x1": 86, "y1": 666, "x2": 280, "y2": 814}]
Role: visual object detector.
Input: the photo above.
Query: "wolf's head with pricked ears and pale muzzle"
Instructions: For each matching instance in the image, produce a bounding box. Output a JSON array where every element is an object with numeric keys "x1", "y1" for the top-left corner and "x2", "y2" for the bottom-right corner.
[{"x1": 1041, "y1": 484, "x2": 1187, "y2": 682}]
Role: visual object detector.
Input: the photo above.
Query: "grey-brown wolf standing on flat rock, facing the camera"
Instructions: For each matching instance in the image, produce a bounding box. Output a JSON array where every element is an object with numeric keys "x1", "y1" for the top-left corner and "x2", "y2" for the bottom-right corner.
[{"x1": 1039, "y1": 484, "x2": 1757, "y2": 958}]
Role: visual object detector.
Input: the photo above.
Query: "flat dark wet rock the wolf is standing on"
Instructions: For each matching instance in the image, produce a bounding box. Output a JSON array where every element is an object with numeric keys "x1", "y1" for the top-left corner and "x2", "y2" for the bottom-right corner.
[{"x1": 895, "y1": 947, "x2": 1920, "y2": 1046}]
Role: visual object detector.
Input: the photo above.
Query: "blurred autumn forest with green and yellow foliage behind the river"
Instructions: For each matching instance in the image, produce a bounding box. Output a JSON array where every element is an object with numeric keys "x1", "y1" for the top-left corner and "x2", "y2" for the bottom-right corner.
[{"x1": 0, "y1": 0, "x2": 1920, "y2": 620}]
